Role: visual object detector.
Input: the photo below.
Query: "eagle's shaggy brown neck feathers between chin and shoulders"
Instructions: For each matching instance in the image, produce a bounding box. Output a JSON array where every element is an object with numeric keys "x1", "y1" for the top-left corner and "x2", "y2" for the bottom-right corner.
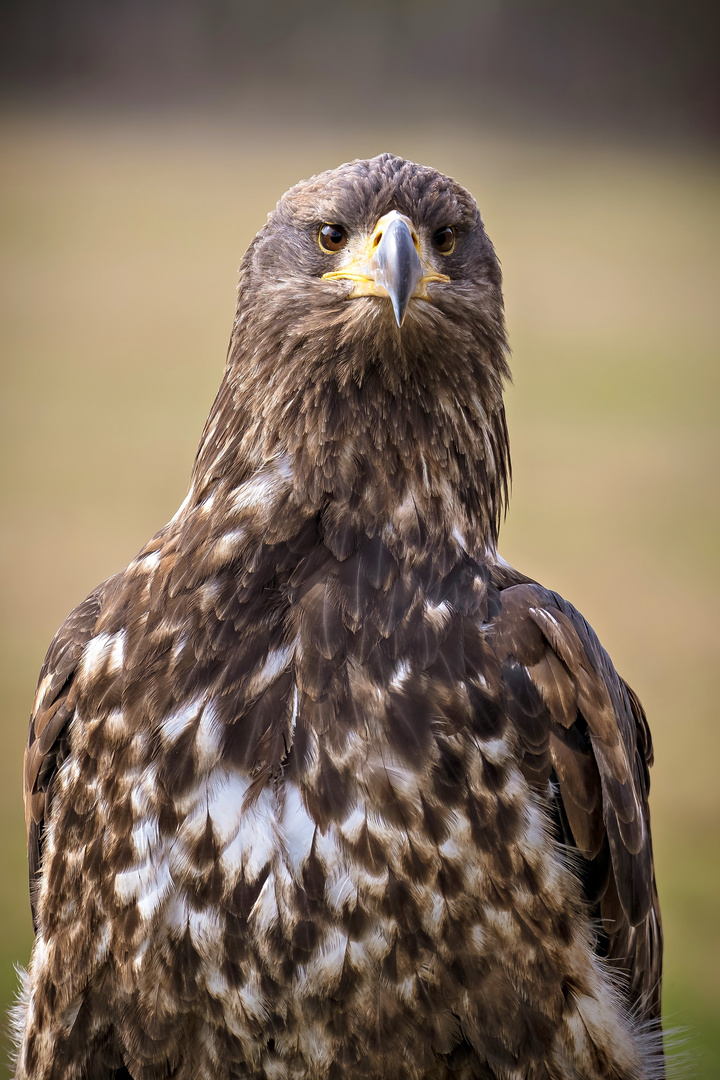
[{"x1": 185, "y1": 287, "x2": 511, "y2": 548}]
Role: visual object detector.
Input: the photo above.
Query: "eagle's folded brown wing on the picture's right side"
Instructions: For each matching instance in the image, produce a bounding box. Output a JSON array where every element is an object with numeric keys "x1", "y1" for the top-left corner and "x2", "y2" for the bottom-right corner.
[{"x1": 493, "y1": 573, "x2": 663, "y2": 1016}]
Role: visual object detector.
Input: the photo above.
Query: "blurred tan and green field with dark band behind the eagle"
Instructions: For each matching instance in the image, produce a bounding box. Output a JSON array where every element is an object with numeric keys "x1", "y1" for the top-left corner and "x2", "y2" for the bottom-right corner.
[{"x1": 0, "y1": 0, "x2": 720, "y2": 1078}]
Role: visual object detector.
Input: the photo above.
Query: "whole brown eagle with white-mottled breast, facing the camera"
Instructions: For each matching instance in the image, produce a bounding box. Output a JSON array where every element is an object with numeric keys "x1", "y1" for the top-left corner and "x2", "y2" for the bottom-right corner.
[{"x1": 14, "y1": 153, "x2": 664, "y2": 1080}]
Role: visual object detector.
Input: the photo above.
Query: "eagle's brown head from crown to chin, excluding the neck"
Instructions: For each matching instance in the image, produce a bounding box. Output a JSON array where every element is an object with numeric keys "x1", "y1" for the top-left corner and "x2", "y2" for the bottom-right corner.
[{"x1": 239, "y1": 153, "x2": 503, "y2": 358}]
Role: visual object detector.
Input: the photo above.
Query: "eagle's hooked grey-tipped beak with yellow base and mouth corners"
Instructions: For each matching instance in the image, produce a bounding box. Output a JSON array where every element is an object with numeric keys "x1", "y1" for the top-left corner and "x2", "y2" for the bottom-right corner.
[{"x1": 323, "y1": 210, "x2": 450, "y2": 326}]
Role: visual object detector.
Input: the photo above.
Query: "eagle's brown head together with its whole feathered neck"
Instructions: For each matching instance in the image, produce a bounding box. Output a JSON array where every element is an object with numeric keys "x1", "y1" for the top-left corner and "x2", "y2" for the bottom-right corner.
[{"x1": 195, "y1": 153, "x2": 510, "y2": 542}]
